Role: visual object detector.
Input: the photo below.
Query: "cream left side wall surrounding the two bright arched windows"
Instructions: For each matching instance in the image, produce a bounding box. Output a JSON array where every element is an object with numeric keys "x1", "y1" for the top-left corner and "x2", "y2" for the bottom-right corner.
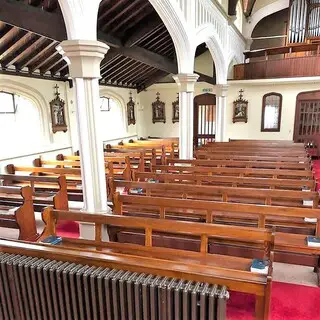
[{"x1": 0, "y1": 75, "x2": 141, "y2": 172}]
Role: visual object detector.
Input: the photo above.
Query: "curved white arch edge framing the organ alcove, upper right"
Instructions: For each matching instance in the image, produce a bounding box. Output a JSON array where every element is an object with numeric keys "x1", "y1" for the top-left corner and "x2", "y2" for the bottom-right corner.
[{"x1": 243, "y1": 0, "x2": 289, "y2": 38}]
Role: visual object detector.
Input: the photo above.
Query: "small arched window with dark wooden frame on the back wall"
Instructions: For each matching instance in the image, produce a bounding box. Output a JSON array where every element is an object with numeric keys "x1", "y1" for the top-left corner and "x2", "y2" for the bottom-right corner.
[{"x1": 261, "y1": 92, "x2": 282, "y2": 132}]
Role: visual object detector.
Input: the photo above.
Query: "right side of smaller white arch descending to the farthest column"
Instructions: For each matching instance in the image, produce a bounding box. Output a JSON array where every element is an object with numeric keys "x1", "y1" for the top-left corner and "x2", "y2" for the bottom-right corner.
[{"x1": 195, "y1": 24, "x2": 228, "y2": 84}]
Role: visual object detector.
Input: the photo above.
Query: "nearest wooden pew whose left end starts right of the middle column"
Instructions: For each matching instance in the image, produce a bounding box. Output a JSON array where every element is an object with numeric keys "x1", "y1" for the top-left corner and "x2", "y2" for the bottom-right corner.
[{"x1": 194, "y1": 150, "x2": 310, "y2": 163}]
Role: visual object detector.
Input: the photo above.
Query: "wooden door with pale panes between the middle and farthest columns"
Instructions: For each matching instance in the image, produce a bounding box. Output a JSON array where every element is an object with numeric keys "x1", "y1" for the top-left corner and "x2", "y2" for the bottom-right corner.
[{"x1": 193, "y1": 93, "x2": 216, "y2": 147}]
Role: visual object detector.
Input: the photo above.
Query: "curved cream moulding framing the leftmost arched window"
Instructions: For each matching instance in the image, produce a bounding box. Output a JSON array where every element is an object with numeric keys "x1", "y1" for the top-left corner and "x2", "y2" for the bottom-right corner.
[{"x1": 0, "y1": 79, "x2": 53, "y2": 143}]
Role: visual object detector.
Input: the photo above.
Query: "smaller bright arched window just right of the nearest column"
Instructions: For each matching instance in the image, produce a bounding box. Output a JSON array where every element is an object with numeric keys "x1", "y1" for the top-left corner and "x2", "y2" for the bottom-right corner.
[{"x1": 100, "y1": 95, "x2": 125, "y2": 139}]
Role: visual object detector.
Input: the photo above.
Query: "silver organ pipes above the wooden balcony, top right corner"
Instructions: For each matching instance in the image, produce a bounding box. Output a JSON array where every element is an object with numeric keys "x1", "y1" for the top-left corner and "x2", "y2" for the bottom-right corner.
[{"x1": 288, "y1": 0, "x2": 320, "y2": 43}]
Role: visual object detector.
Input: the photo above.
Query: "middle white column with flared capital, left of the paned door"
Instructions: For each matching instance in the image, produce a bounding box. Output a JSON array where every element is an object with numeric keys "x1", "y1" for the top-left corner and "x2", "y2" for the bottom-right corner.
[{"x1": 173, "y1": 73, "x2": 199, "y2": 159}]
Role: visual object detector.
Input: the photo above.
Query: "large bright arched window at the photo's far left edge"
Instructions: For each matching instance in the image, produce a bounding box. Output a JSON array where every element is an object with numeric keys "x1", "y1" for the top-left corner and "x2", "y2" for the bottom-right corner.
[{"x1": 0, "y1": 92, "x2": 43, "y2": 152}]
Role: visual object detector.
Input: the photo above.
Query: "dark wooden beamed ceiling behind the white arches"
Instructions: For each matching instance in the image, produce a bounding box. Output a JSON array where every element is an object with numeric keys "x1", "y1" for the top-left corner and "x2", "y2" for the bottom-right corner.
[{"x1": 0, "y1": 0, "x2": 213, "y2": 91}]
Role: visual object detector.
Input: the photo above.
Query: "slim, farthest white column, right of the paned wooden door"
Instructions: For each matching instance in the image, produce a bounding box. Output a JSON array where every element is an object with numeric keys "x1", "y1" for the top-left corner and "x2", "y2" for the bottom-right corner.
[{"x1": 216, "y1": 84, "x2": 228, "y2": 142}]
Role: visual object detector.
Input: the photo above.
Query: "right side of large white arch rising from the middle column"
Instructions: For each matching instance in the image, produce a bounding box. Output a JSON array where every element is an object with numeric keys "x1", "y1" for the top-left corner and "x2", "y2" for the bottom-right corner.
[{"x1": 149, "y1": 0, "x2": 195, "y2": 73}]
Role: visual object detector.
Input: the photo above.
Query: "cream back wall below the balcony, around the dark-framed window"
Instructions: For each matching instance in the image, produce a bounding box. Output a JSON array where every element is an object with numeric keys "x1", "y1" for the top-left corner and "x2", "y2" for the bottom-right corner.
[{"x1": 226, "y1": 79, "x2": 319, "y2": 140}]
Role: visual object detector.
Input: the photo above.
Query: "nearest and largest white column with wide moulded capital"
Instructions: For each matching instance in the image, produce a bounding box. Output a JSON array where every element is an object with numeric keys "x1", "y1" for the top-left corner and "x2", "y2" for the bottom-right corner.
[{"x1": 58, "y1": 40, "x2": 110, "y2": 213}]
